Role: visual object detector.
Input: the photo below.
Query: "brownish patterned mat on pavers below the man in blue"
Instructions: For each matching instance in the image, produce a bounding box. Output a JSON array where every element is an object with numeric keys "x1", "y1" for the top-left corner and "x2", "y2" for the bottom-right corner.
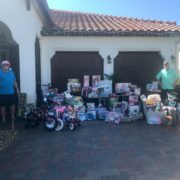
[{"x1": 0, "y1": 130, "x2": 18, "y2": 151}]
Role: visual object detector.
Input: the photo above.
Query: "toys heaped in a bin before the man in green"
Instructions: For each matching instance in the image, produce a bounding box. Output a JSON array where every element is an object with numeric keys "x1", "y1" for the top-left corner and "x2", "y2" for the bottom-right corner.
[{"x1": 141, "y1": 87, "x2": 180, "y2": 125}]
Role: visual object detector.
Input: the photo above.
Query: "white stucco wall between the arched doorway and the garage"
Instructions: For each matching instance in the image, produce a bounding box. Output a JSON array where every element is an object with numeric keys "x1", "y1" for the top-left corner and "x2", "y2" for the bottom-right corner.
[{"x1": 0, "y1": 0, "x2": 42, "y2": 102}]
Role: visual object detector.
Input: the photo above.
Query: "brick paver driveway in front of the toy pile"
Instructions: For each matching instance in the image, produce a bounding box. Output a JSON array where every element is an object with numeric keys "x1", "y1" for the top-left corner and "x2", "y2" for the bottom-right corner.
[{"x1": 0, "y1": 121, "x2": 180, "y2": 180}]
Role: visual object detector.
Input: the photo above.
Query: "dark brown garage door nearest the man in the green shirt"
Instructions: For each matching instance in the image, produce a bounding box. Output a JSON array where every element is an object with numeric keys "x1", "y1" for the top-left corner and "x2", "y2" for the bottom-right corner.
[{"x1": 114, "y1": 52, "x2": 162, "y2": 92}]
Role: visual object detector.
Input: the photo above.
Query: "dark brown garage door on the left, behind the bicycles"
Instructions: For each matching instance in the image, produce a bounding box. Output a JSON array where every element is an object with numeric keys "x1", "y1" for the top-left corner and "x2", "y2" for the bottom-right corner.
[{"x1": 51, "y1": 52, "x2": 103, "y2": 92}]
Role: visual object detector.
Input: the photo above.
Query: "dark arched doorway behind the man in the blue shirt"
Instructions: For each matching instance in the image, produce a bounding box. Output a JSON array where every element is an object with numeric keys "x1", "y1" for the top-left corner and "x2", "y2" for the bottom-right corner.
[{"x1": 0, "y1": 21, "x2": 20, "y2": 86}]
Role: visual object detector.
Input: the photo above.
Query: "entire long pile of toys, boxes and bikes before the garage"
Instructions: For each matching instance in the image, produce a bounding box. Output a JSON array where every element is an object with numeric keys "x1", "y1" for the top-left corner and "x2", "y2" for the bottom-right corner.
[{"x1": 22, "y1": 79, "x2": 180, "y2": 131}]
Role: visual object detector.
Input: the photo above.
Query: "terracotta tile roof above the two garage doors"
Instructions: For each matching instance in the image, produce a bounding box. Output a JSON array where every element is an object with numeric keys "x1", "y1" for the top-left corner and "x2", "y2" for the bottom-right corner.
[{"x1": 42, "y1": 10, "x2": 180, "y2": 36}]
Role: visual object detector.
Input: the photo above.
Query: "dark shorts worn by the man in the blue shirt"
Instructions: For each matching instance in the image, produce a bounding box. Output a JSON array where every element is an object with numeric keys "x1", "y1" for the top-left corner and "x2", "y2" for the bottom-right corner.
[{"x1": 0, "y1": 94, "x2": 16, "y2": 107}]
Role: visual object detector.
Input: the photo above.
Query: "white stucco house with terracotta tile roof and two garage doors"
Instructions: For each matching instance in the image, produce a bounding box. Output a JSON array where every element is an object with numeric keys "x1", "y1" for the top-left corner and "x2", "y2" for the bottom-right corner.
[{"x1": 0, "y1": 0, "x2": 180, "y2": 102}]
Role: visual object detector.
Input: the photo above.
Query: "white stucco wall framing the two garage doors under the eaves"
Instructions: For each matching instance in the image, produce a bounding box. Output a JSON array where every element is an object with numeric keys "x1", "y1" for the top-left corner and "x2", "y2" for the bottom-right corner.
[{"x1": 41, "y1": 37, "x2": 180, "y2": 87}]
